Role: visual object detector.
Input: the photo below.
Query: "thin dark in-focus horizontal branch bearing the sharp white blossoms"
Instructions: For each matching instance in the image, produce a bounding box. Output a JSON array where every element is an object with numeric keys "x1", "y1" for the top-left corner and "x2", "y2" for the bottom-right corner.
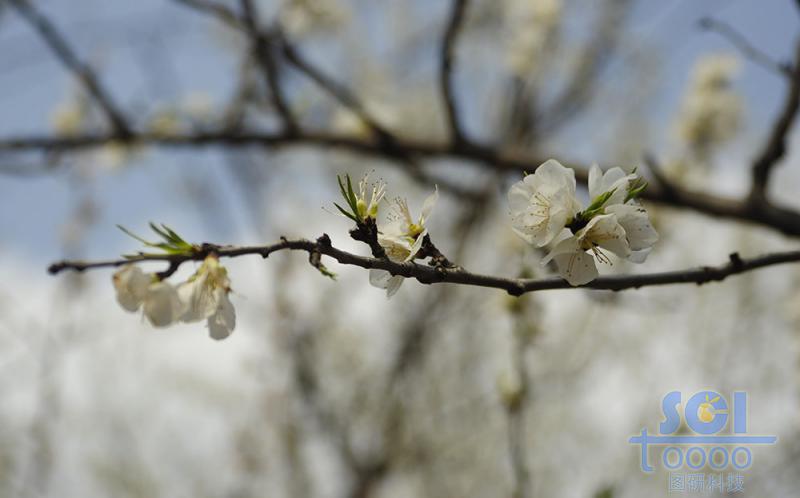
[{"x1": 48, "y1": 235, "x2": 800, "y2": 296}]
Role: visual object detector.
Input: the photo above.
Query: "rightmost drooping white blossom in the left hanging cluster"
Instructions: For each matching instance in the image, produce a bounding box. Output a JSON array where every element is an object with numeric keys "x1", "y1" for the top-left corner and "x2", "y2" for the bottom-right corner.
[{"x1": 178, "y1": 256, "x2": 236, "y2": 339}]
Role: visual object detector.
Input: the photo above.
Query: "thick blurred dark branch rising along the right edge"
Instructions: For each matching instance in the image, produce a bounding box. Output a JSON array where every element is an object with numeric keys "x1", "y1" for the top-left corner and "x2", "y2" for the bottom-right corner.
[{"x1": 750, "y1": 36, "x2": 800, "y2": 205}]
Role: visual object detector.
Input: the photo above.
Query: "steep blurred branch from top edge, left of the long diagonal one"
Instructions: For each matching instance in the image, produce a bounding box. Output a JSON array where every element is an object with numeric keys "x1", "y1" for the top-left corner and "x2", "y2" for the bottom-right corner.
[{"x1": 240, "y1": 0, "x2": 298, "y2": 134}]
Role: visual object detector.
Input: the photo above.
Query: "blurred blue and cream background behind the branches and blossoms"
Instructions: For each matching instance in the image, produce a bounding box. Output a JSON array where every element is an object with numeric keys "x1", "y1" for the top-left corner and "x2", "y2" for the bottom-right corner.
[{"x1": 0, "y1": 0, "x2": 800, "y2": 498}]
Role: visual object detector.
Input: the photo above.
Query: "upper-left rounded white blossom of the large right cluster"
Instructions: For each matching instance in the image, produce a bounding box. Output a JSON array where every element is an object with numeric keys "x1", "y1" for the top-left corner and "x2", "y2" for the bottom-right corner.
[{"x1": 508, "y1": 159, "x2": 580, "y2": 247}]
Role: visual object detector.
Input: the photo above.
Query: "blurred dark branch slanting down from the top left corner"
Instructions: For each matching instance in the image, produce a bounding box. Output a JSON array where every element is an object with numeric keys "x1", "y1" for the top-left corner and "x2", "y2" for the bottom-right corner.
[{"x1": 9, "y1": 0, "x2": 131, "y2": 137}]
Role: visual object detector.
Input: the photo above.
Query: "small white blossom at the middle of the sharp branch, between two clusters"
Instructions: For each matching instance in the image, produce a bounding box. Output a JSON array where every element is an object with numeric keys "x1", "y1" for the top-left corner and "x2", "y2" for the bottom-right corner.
[{"x1": 369, "y1": 188, "x2": 439, "y2": 297}]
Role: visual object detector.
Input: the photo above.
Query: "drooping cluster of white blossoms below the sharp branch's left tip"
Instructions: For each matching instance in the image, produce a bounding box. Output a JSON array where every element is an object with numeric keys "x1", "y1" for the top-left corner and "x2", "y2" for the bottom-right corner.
[{"x1": 113, "y1": 255, "x2": 236, "y2": 340}]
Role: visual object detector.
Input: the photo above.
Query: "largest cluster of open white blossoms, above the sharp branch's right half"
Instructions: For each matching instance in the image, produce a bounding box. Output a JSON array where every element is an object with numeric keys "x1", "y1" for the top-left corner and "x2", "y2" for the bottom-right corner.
[{"x1": 508, "y1": 159, "x2": 658, "y2": 286}]
